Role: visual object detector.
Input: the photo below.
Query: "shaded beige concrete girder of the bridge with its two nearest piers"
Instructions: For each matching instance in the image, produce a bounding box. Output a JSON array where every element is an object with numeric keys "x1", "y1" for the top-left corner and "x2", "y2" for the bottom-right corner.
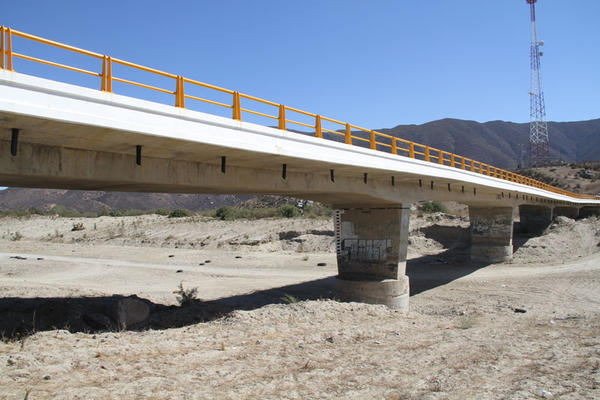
[{"x1": 0, "y1": 141, "x2": 528, "y2": 310}]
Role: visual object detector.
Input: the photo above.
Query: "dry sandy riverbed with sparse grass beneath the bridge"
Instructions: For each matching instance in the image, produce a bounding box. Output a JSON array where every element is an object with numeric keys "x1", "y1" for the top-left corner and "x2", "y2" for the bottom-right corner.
[{"x1": 0, "y1": 214, "x2": 600, "y2": 399}]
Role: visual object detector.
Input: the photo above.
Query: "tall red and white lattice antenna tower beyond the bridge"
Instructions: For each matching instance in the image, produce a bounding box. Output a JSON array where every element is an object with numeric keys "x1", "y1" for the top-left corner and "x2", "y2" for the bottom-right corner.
[{"x1": 525, "y1": 0, "x2": 550, "y2": 166}]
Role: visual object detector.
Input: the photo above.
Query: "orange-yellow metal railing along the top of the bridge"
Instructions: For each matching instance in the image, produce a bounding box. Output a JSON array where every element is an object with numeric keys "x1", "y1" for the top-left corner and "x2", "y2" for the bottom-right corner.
[{"x1": 0, "y1": 26, "x2": 597, "y2": 199}]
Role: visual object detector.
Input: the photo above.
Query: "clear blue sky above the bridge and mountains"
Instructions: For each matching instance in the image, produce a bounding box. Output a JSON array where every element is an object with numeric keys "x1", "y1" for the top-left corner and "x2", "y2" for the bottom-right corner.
[{"x1": 0, "y1": 0, "x2": 600, "y2": 129}]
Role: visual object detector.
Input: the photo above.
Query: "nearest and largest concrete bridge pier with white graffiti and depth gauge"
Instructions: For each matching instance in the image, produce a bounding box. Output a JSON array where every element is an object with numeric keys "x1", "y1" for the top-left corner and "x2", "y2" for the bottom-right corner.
[{"x1": 334, "y1": 207, "x2": 410, "y2": 311}]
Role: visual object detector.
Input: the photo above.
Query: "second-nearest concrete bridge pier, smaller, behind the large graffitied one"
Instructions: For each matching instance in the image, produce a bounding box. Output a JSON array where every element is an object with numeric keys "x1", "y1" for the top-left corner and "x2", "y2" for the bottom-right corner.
[{"x1": 469, "y1": 206, "x2": 513, "y2": 263}]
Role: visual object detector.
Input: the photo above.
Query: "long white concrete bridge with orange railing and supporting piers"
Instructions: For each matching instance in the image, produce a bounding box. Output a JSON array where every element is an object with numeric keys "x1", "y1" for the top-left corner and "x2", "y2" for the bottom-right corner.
[{"x1": 0, "y1": 27, "x2": 600, "y2": 309}]
